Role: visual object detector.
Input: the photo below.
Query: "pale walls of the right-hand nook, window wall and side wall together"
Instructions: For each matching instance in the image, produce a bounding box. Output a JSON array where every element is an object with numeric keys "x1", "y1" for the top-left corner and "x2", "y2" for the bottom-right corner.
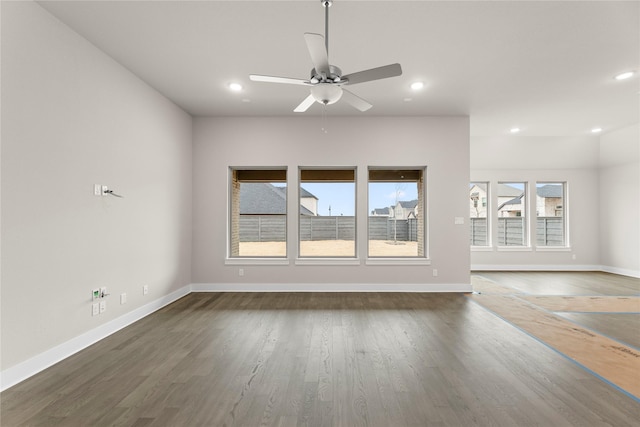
[{"x1": 471, "y1": 131, "x2": 640, "y2": 277}]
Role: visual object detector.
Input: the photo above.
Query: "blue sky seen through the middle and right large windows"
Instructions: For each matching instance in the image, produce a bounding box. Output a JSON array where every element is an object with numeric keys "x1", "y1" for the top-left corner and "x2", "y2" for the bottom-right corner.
[{"x1": 302, "y1": 182, "x2": 418, "y2": 216}]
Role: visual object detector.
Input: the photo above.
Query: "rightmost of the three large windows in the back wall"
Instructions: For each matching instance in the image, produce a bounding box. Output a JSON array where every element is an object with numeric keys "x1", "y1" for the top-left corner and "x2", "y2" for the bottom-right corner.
[{"x1": 368, "y1": 168, "x2": 425, "y2": 258}]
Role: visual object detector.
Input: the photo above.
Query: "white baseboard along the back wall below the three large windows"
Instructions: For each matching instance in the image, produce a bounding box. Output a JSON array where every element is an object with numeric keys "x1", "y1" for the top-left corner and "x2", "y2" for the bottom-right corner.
[{"x1": 191, "y1": 283, "x2": 472, "y2": 292}]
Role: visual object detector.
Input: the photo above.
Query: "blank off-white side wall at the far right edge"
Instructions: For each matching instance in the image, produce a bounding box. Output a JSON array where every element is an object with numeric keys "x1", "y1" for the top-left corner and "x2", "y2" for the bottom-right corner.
[{"x1": 599, "y1": 125, "x2": 640, "y2": 277}]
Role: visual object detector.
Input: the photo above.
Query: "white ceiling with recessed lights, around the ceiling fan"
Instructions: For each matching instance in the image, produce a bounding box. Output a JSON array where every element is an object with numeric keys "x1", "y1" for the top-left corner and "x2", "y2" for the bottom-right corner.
[{"x1": 39, "y1": 0, "x2": 640, "y2": 136}]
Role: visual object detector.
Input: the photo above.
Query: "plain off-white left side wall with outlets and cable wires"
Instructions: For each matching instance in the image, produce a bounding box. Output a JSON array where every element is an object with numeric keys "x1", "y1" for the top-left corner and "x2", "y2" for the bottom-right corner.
[{"x1": 1, "y1": 2, "x2": 192, "y2": 371}]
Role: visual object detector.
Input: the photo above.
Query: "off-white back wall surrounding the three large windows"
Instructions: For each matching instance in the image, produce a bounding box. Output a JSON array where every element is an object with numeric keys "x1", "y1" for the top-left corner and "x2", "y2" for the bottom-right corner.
[{"x1": 192, "y1": 117, "x2": 469, "y2": 289}]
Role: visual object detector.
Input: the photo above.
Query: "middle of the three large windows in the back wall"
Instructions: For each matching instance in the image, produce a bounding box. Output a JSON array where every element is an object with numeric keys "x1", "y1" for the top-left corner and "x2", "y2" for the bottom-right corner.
[{"x1": 298, "y1": 168, "x2": 356, "y2": 257}]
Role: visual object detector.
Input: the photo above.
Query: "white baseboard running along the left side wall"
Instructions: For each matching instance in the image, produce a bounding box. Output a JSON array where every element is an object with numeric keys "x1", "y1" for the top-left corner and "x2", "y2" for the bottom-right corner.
[{"x1": 0, "y1": 286, "x2": 191, "y2": 391}]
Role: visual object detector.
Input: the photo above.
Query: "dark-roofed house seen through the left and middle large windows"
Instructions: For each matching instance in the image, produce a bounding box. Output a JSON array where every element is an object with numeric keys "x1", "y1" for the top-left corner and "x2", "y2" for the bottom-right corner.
[{"x1": 240, "y1": 183, "x2": 318, "y2": 216}]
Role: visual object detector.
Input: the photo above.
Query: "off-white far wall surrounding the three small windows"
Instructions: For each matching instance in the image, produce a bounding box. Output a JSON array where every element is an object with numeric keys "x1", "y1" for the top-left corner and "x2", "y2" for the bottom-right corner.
[{"x1": 471, "y1": 136, "x2": 600, "y2": 270}]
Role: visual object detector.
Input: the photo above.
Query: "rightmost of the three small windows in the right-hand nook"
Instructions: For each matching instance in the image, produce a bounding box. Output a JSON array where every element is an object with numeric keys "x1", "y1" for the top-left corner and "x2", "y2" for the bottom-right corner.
[{"x1": 536, "y1": 182, "x2": 566, "y2": 246}]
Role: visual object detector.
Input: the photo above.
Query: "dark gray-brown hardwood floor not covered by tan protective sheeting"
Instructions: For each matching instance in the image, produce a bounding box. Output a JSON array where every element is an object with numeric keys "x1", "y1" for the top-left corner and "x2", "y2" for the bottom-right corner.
[{"x1": 0, "y1": 273, "x2": 640, "y2": 427}]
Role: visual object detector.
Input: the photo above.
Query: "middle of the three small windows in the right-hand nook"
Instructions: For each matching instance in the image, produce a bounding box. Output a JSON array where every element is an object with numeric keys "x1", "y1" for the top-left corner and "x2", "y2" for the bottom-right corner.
[{"x1": 496, "y1": 182, "x2": 528, "y2": 246}]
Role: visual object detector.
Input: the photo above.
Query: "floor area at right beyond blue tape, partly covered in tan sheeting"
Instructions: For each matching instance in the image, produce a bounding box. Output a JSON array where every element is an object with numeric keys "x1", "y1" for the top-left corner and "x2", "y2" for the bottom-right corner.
[{"x1": 470, "y1": 273, "x2": 640, "y2": 401}]
